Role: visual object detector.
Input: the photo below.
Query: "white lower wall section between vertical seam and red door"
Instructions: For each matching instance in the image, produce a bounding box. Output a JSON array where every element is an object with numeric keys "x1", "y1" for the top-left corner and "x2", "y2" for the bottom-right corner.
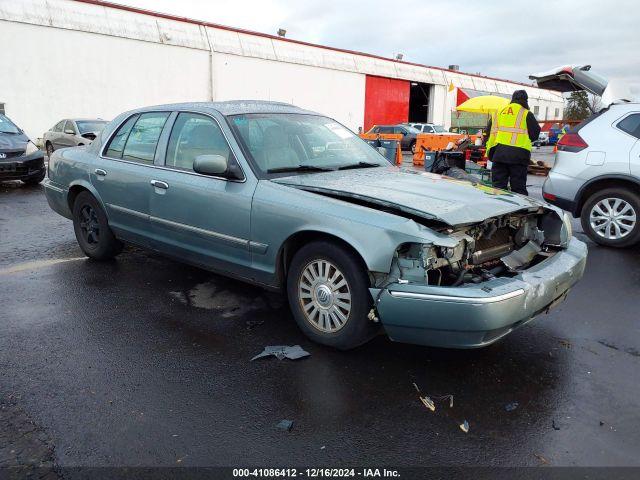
[{"x1": 213, "y1": 53, "x2": 365, "y2": 132}]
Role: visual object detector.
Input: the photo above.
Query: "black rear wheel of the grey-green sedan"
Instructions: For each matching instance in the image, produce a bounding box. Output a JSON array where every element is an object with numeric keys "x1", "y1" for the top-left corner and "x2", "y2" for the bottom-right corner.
[{"x1": 73, "y1": 192, "x2": 122, "y2": 260}]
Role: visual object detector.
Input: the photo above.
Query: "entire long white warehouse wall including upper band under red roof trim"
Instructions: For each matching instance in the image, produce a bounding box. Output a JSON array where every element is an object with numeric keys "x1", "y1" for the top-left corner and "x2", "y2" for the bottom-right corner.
[{"x1": 0, "y1": 0, "x2": 564, "y2": 138}]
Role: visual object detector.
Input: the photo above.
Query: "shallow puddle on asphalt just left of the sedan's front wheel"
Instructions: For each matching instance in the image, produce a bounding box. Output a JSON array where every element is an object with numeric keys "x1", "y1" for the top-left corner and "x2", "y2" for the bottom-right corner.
[{"x1": 169, "y1": 281, "x2": 284, "y2": 318}]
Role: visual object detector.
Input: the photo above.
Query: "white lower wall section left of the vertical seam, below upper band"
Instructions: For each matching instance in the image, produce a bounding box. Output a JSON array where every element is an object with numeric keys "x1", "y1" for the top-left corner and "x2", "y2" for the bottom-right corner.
[{"x1": 0, "y1": 20, "x2": 209, "y2": 140}]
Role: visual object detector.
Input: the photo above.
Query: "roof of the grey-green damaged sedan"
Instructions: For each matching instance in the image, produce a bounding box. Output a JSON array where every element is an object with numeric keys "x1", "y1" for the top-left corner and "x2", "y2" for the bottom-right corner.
[{"x1": 129, "y1": 100, "x2": 320, "y2": 116}]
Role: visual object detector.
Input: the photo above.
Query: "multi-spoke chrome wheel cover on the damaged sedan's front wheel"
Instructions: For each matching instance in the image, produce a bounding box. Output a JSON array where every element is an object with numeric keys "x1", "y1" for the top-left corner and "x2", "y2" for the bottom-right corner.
[{"x1": 298, "y1": 260, "x2": 352, "y2": 333}]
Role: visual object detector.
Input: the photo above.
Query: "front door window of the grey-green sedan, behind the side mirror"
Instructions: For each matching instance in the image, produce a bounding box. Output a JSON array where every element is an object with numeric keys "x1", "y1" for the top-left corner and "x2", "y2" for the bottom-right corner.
[{"x1": 165, "y1": 113, "x2": 233, "y2": 171}]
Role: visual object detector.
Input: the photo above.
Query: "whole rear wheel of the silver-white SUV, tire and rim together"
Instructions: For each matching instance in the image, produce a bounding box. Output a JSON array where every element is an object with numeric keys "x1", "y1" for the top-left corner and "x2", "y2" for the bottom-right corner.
[{"x1": 580, "y1": 188, "x2": 640, "y2": 247}]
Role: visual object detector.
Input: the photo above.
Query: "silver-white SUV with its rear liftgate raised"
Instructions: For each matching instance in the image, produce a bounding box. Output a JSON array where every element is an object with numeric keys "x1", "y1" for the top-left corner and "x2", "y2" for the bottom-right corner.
[{"x1": 534, "y1": 67, "x2": 640, "y2": 247}]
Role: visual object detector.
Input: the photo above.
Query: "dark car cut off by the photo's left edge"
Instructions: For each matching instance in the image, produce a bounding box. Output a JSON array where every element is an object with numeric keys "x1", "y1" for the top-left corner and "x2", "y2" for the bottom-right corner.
[{"x1": 0, "y1": 113, "x2": 47, "y2": 185}]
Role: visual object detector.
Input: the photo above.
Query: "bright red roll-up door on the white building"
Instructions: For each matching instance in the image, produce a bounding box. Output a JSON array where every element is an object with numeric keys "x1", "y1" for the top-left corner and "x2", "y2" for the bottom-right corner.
[{"x1": 364, "y1": 75, "x2": 411, "y2": 132}]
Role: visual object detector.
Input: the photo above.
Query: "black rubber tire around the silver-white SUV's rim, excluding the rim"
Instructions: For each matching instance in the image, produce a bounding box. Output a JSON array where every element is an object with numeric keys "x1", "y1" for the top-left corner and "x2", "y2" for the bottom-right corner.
[{"x1": 580, "y1": 188, "x2": 640, "y2": 248}]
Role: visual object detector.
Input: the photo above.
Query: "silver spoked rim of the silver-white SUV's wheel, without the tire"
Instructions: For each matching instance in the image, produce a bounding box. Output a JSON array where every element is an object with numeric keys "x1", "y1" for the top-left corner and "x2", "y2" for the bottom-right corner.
[{"x1": 589, "y1": 198, "x2": 637, "y2": 240}]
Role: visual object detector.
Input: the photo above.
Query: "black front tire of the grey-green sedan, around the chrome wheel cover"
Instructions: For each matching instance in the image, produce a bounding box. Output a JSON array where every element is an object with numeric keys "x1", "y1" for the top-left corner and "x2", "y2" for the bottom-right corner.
[{"x1": 287, "y1": 241, "x2": 379, "y2": 350}]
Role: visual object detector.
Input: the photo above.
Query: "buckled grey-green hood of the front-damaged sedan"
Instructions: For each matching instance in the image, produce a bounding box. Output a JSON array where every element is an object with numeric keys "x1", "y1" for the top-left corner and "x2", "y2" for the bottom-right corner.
[{"x1": 272, "y1": 167, "x2": 545, "y2": 226}]
